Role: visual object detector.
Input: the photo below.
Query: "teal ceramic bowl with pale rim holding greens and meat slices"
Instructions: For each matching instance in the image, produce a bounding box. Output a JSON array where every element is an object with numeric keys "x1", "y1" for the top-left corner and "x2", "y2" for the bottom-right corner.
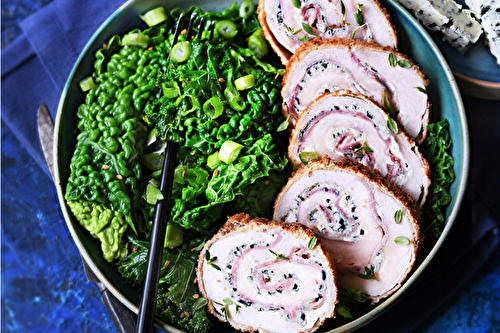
[{"x1": 54, "y1": 0, "x2": 469, "y2": 332}]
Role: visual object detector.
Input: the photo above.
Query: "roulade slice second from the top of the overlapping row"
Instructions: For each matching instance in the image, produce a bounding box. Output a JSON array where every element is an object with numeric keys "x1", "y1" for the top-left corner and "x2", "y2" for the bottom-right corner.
[{"x1": 281, "y1": 39, "x2": 430, "y2": 144}]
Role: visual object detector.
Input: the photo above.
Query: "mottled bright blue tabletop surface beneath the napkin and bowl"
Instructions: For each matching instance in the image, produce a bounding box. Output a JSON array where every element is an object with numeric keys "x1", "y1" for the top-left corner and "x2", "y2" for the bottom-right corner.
[{"x1": 1, "y1": 0, "x2": 500, "y2": 333}]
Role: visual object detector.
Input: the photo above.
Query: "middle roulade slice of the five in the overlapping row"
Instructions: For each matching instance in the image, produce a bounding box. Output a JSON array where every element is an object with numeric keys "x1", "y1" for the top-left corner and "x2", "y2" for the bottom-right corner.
[{"x1": 288, "y1": 90, "x2": 430, "y2": 205}]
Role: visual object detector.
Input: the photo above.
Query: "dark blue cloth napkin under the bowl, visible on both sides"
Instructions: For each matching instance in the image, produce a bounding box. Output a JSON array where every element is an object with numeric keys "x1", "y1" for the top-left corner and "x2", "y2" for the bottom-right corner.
[{"x1": 1, "y1": 0, "x2": 500, "y2": 332}]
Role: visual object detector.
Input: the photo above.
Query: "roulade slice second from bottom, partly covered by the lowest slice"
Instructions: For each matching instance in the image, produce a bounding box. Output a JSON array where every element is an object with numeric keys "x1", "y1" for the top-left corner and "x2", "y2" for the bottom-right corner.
[{"x1": 274, "y1": 158, "x2": 421, "y2": 302}]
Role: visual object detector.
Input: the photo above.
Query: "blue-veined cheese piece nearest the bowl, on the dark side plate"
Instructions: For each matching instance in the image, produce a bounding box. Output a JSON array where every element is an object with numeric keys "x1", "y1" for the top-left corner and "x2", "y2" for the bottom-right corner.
[{"x1": 398, "y1": 0, "x2": 483, "y2": 53}]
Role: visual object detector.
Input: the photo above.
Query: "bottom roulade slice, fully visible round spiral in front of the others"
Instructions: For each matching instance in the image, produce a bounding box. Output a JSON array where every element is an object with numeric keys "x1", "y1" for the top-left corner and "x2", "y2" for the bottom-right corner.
[{"x1": 197, "y1": 213, "x2": 337, "y2": 332}]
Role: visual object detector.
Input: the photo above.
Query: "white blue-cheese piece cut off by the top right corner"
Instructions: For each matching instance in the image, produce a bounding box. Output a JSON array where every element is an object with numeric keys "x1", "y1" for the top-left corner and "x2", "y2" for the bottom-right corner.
[{"x1": 465, "y1": 0, "x2": 500, "y2": 65}]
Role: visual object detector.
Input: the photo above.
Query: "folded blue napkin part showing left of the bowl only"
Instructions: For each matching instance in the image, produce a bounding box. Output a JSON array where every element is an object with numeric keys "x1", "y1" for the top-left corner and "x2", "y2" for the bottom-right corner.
[{"x1": 1, "y1": 0, "x2": 124, "y2": 179}]
